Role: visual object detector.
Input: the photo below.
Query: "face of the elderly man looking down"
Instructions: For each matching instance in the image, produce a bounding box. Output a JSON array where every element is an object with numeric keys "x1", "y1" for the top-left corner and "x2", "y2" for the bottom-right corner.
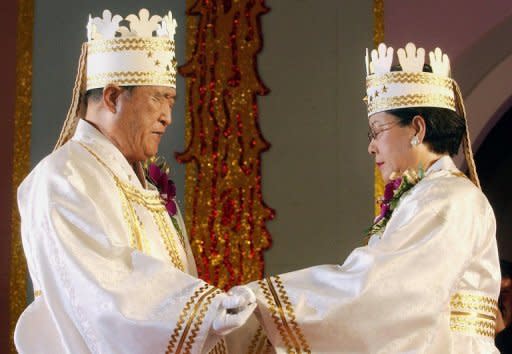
[{"x1": 114, "y1": 86, "x2": 176, "y2": 162}]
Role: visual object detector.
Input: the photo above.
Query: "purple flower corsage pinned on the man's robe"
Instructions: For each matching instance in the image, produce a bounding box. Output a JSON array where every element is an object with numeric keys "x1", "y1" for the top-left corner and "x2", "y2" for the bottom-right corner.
[{"x1": 143, "y1": 156, "x2": 183, "y2": 238}]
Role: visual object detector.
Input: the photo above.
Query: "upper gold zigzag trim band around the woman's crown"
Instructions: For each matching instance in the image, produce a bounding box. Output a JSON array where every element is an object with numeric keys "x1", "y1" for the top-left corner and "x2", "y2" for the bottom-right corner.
[{"x1": 366, "y1": 71, "x2": 453, "y2": 90}]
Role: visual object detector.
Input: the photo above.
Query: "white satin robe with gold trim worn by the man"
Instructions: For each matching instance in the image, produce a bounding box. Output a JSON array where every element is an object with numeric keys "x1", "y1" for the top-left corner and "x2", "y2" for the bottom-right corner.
[{"x1": 15, "y1": 120, "x2": 223, "y2": 354}]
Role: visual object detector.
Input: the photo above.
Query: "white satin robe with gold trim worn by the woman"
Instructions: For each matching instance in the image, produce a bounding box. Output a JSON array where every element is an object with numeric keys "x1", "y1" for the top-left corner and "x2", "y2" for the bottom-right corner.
[{"x1": 250, "y1": 156, "x2": 500, "y2": 354}]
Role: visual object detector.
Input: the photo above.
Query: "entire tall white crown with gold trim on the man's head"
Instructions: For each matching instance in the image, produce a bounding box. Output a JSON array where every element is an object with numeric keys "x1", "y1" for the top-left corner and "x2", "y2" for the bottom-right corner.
[{"x1": 86, "y1": 9, "x2": 177, "y2": 90}]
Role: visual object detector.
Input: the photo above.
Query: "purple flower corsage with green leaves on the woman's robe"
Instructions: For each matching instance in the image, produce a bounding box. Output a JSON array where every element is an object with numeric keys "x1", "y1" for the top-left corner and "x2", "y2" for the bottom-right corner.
[{"x1": 366, "y1": 167, "x2": 425, "y2": 240}]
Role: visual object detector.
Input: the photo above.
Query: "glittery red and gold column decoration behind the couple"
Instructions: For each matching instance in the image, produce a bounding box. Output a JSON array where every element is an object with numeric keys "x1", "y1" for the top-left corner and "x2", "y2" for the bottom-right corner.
[{"x1": 177, "y1": 0, "x2": 274, "y2": 289}]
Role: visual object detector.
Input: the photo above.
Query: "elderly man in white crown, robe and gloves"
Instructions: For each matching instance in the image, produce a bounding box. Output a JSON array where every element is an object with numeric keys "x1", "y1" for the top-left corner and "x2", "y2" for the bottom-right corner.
[{"x1": 15, "y1": 9, "x2": 255, "y2": 354}]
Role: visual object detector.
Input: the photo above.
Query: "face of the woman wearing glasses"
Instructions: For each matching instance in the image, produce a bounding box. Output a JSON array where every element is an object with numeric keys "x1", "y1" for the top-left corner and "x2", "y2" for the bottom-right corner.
[{"x1": 368, "y1": 112, "x2": 419, "y2": 182}]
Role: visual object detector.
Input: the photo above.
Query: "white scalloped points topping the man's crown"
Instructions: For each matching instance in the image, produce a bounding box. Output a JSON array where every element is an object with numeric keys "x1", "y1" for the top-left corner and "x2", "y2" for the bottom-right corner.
[{"x1": 87, "y1": 9, "x2": 178, "y2": 42}]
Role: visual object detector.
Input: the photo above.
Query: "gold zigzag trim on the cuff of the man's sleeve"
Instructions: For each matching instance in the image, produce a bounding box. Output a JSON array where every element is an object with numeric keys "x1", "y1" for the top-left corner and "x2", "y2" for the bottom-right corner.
[{"x1": 165, "y1": 284, "x2": 221, "y2": 354}]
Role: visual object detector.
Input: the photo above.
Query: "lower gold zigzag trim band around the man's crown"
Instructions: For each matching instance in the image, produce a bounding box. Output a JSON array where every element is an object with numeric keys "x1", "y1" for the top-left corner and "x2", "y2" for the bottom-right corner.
[{"x1": 87, "y1": 71, "x2": 176, "y2": 89}]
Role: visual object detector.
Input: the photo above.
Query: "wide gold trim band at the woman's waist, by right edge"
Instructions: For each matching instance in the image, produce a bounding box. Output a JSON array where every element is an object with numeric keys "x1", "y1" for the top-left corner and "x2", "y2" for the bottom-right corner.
[{"x1": 450, "y1": 293, "x2": 498, "y2": 338}]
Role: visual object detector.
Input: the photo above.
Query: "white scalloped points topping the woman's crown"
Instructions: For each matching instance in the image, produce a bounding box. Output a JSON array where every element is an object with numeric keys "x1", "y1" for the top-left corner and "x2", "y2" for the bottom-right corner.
[{"x1": 366, "y1": 43, "x2": 450, "y2": 77}]
